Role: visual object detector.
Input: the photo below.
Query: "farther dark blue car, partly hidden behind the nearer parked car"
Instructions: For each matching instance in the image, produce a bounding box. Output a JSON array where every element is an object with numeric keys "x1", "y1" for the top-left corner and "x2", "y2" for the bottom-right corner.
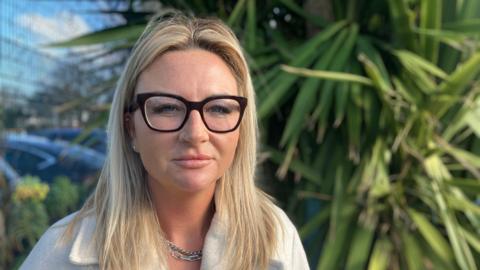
[{"x1": 29, "y1": 128, "x2": 107, "y2": 154}]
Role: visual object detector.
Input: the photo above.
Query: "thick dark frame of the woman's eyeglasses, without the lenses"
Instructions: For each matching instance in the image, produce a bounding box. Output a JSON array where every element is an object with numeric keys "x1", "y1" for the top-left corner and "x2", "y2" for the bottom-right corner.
[{"x1": 126, "y1": 92, "x2": 248, "y2": 133}]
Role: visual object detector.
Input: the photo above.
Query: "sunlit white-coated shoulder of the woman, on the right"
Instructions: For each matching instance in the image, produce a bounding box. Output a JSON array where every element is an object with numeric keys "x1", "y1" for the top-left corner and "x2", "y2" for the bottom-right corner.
[{"x1": 273, "y1": 206, "x2": 310, "y2": 270}]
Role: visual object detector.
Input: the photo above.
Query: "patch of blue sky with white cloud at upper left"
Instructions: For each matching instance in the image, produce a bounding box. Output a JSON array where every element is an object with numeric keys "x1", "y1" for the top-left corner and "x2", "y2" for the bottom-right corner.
[{"x1": 0, "y1": 0, "x2": 124, "y2": 95}]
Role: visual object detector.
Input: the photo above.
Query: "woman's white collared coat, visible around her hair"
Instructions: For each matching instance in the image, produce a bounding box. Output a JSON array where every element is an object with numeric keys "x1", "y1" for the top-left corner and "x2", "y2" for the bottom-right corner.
[{"x1": 20, "y1": 208, "x2": 310, "y2": 270}]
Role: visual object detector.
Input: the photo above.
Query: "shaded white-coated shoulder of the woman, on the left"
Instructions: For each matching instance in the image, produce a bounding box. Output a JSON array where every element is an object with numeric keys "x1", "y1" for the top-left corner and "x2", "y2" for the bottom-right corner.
[{"x1": 20, "y1": 212, "x2": 95, "y2": 270}]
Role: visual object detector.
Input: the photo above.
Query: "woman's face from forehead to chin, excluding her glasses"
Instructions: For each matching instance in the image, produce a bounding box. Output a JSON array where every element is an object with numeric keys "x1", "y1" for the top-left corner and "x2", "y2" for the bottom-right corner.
[{"x1": 130, "y1": 49, "x2": 239, "y2": 192}]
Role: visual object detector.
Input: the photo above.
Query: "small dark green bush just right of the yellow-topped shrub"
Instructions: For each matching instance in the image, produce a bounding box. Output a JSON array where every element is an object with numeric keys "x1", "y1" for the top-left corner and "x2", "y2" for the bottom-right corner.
[{"x1": 45, "y1": 177, "x2": 79, "y2": 222}]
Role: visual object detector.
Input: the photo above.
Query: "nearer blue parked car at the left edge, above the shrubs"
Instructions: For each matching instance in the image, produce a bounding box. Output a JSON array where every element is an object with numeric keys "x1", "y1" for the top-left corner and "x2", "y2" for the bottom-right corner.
[{"x1": 0, "y1": 133, "x2": 105, "y2": 182}]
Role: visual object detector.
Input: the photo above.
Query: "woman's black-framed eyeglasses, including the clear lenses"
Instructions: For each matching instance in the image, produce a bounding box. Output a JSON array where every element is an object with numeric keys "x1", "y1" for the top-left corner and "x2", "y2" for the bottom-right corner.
[{"x1": 127, "y1": 93, "x2": 247, "y2": 133}]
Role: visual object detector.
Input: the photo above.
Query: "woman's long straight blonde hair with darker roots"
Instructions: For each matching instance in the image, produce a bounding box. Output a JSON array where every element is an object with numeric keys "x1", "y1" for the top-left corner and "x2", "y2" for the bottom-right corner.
[{"x1": 69, "y1": 13, "x2": 281, "y2": 270}]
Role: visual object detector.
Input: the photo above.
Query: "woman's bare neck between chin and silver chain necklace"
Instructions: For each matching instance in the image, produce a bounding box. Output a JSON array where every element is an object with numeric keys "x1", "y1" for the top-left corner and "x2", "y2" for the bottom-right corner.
[{"x1": 148, "y1": 177, "x2": 215, "y2": 250}]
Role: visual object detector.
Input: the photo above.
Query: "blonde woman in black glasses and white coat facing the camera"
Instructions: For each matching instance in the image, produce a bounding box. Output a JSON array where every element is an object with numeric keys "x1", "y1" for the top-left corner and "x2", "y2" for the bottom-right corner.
[{"x1": 22, "y1": 11, "x2": 308, "y2": 270}]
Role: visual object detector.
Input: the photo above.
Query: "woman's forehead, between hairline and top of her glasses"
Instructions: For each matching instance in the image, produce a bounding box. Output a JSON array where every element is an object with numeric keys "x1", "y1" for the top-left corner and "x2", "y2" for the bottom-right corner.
[{"x1": 135, "y1": 49, "x2": 239, "y2": 100}]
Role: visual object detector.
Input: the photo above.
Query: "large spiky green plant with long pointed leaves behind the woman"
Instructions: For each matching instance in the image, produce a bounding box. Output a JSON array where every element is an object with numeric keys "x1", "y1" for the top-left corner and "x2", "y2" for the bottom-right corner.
[{"x1": 46, "y1": 0, "x2": 480, "y2": 270}]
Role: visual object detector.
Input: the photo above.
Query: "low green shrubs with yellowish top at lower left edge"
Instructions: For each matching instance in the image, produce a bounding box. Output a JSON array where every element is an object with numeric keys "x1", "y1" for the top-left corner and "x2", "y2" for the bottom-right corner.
[{"x1": 0, "y1": 176, "x2": 81, "y2": 269}]
